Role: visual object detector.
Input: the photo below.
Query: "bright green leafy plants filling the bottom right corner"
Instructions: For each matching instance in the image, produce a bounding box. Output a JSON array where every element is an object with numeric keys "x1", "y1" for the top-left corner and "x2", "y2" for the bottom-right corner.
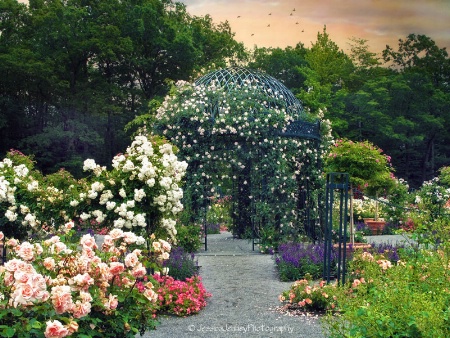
[{"x1": 326, "y1": 249, "x2": 450, "y2": 338}]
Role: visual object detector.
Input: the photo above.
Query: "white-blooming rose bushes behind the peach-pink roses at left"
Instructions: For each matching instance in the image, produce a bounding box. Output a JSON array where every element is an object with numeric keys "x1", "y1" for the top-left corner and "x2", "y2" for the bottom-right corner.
[{"x1": 0, "y1": 134, "x2": 187, "y2": 240}]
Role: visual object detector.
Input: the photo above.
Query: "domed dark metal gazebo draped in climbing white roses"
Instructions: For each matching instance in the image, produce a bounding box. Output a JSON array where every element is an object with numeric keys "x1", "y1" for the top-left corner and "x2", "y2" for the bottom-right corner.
[{"x1": 155, "y1": 67, "x2": 322, "y2": 247}]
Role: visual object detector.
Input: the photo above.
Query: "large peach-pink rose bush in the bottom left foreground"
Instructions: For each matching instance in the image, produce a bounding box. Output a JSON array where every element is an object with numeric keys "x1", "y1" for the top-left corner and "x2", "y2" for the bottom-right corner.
[{"x1": 0, "y1": 227, "x2": 168, "y2": 338}]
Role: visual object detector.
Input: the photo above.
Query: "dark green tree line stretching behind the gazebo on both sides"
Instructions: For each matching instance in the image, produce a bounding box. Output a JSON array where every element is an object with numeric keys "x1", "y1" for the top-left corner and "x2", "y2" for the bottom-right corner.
[{"x1": 0, "y1": 0, "x2": 450, "y2": 188}]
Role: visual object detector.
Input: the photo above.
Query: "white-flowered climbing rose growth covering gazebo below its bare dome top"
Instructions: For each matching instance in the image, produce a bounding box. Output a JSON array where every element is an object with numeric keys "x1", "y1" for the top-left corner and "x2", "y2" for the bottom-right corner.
[{"x1": 155, "y1": 82, "x2": 330, "y2": 240}]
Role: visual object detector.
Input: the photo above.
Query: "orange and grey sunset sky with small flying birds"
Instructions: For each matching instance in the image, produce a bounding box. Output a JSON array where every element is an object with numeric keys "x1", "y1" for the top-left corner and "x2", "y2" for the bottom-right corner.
[{"x1": 179, "y1": 0, "x2": 450, "y2": 53}]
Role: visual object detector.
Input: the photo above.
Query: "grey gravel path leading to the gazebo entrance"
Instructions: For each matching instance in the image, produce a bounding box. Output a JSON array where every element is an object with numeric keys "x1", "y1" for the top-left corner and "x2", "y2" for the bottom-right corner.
[{"x1": 140, "y1": 232, "x2": 325, "y2": 338}]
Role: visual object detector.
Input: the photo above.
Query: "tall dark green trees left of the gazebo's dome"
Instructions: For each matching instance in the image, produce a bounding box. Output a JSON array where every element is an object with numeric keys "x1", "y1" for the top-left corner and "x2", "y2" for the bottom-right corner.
[{"x1": 0, "y1": 0, "x2": 245, "y2": 177}]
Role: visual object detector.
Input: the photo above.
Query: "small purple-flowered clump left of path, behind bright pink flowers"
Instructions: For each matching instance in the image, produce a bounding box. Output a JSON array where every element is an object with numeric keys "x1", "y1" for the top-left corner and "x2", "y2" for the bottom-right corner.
[{"x1": 164, "y1": 247, "x2": 198, "y2": 280}]
